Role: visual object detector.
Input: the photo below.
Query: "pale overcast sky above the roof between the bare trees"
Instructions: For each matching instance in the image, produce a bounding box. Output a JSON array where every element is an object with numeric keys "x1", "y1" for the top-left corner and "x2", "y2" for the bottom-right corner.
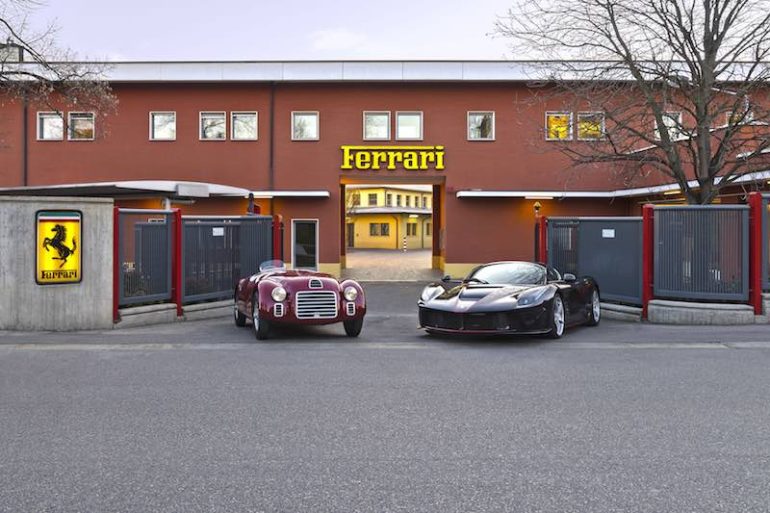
[{"x1": 27, "y1": 0, "x2": 514, "y2": 60}]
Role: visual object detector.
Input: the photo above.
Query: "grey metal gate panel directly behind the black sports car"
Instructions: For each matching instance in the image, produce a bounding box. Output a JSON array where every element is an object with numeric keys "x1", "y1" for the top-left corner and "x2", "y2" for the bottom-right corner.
[{"x1": 547, "y1": 217, "x2": 642, "y2": 305}]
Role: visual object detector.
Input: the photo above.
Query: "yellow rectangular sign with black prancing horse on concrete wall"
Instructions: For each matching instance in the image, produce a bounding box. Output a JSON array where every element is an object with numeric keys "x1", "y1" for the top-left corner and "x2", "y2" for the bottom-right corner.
[{"x1": 35, "y1": 210, "x2": 83, "y2": 285}]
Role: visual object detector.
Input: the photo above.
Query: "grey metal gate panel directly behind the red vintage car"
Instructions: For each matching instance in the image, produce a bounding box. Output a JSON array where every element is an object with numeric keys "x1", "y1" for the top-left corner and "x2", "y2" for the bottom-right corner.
[{"x1": 182, "y1": 216, "x2": 273, "y2": 304}]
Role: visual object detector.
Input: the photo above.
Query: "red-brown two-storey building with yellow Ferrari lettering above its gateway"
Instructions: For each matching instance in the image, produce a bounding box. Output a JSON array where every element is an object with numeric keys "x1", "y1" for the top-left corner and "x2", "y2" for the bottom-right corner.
[{"x1": 0, "y1": 62, "x2": 764, "y2": 274}]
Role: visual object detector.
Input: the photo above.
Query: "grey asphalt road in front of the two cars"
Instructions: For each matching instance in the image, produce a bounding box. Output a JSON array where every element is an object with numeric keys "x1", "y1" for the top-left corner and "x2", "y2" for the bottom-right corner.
[{"x1": 0, "y1": 284, "x2": 770, "y2": 513}]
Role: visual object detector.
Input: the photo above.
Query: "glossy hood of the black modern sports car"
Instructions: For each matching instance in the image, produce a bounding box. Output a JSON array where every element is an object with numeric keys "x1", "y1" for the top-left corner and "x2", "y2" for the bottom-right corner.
[{"x1": 423, "y1": 283, "x2": 544, "y2": 312}]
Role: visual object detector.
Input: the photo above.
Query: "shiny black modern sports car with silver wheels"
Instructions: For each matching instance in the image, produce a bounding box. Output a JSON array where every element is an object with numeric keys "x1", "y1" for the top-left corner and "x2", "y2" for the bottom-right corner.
[{"x1": 417, "y1": 262, "x2": 601, "y2": 338}]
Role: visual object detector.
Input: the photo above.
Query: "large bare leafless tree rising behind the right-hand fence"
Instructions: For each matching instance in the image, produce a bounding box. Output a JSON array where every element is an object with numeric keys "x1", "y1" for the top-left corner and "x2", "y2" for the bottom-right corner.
[{"x1": 496, "y1": 0, "x2": 770, "y2": 204}]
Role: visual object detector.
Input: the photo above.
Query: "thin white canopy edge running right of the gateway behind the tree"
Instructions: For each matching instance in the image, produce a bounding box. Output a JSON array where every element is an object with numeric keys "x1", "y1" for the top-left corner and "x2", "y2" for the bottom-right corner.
[{"x1": 456, "y1": 171, "x2": 770, "y2": 199}]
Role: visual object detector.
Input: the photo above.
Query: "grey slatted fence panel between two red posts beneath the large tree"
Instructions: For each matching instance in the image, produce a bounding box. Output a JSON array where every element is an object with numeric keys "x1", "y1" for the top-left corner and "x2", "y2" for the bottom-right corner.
[{"x1": 654, "y1": 205, "x2": 749, "y2": 301}]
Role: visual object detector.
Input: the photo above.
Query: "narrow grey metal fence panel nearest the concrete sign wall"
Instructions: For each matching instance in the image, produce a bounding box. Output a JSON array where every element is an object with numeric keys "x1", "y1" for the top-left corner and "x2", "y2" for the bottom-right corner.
[{"x1": 117, "y1": 209, "x2": 174, "y2": 306}]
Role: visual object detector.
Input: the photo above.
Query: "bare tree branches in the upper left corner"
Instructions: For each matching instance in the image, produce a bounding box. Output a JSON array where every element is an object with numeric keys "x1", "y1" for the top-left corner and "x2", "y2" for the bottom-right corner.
[{"x1": 0, "y1": 0, "x2": 116, "y2": 112}]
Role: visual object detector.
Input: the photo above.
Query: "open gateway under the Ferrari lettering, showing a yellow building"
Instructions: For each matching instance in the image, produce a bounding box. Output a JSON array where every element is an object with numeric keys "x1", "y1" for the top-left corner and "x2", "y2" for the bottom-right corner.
[{"x1": 341, "y1": 183, "x2": 441, "y2": 281}]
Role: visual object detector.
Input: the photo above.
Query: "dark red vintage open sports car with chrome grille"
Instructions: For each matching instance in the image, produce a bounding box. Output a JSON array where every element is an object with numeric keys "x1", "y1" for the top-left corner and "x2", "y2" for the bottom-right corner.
[{"x1": 233, "y1": 260, "x2": 366, "y2": 340}]
